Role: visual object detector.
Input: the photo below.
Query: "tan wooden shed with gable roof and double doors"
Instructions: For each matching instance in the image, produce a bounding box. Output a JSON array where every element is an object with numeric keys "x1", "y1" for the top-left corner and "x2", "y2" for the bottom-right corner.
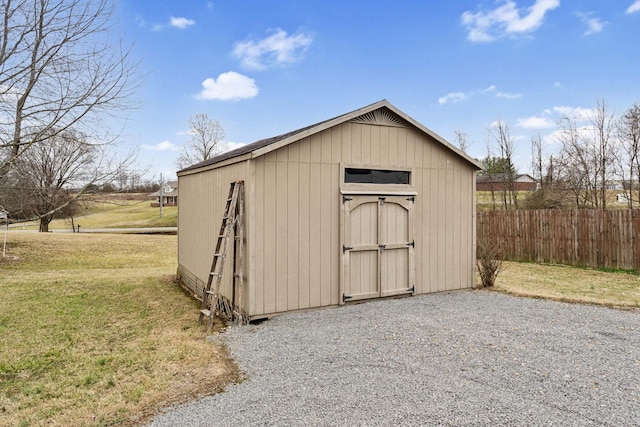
[{"x1": 178, "y1": 100, "x2": 481, "y2": 320}]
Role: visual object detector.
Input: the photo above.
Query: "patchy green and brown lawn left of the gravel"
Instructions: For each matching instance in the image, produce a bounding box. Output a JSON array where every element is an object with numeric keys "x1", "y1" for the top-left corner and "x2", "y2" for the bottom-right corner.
[{"x1": 0, "y1": 232, "x2": 238, "y2": 426}]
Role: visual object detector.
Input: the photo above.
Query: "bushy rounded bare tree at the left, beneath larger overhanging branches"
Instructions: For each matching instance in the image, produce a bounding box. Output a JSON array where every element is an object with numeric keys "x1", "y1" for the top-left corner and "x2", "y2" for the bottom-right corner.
[{"x1": 0, "y1": 131, "x2": 134, "y2": 232}]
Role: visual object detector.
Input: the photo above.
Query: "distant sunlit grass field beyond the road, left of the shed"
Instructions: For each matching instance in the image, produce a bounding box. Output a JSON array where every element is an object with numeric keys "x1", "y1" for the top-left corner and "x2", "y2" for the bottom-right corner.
[{"x1": 12, "y1": 200, "x2": 178, "y2": 231}]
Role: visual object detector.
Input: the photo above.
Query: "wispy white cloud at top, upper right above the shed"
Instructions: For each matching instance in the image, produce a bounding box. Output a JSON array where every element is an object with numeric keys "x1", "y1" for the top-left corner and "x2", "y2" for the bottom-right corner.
[{"x1": 461, "y1": 0, "x2": 560, "y2": 42}]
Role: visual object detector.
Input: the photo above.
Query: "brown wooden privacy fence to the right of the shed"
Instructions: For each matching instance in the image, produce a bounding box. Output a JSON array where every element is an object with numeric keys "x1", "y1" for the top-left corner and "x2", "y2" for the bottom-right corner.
[{"x1": 477, "y1": 209, "x2": 640, "y2": 270}]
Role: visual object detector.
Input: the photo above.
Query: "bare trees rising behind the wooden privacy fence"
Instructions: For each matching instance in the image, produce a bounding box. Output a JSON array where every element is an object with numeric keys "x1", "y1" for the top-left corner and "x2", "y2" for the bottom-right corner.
[{"x1": 478, "y1": 100, "x2": 640, "y2": 209}]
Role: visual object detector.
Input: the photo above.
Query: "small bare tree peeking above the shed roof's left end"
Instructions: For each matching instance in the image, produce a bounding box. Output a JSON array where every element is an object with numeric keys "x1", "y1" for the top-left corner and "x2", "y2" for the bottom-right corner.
[{"x1": 176, "y1": 113, "x2": 225, "y2": 169}]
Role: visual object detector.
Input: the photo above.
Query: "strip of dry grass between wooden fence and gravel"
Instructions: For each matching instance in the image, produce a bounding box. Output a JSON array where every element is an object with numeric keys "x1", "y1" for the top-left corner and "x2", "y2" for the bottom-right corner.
[{"x1": 494, "y1": 262, "x2": 640, "y2": 308}]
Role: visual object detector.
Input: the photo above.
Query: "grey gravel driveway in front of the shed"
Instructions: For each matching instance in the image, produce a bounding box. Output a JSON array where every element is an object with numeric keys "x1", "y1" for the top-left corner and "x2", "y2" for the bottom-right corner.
[{"x1": 146, "y1": 291, "x2": 640, "y2": 427}]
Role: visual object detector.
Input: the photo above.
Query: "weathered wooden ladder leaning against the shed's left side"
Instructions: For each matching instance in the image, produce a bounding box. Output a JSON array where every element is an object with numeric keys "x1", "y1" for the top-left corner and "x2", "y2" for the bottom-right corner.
[{"x1": 199, "y1": 181, "x2": 244, "y2": 331}]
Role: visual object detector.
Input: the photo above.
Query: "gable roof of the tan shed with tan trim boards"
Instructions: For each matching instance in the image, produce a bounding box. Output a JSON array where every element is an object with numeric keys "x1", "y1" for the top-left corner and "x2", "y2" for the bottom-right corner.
[{"x1": 178, "y1": 99, "x2": 482, "y2": 174}]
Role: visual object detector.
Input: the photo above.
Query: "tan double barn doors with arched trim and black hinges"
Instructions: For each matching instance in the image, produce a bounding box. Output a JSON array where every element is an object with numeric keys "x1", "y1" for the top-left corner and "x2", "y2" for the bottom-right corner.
[{"x1": 342, "y1": 195, "x2": 415, "y2": 302}]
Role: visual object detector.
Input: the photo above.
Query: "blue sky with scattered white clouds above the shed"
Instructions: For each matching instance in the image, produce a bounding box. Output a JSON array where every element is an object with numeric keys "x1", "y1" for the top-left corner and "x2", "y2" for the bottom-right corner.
[{"x1": 118, "y1": 0, "x2": 640, "y2": 179}]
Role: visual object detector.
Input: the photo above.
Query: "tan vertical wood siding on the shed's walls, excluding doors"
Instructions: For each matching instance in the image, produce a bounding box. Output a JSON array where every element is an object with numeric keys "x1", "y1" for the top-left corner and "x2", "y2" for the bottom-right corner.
[{"x1": 179, "y1": 118, "x2": 475, "y2": 316}]
